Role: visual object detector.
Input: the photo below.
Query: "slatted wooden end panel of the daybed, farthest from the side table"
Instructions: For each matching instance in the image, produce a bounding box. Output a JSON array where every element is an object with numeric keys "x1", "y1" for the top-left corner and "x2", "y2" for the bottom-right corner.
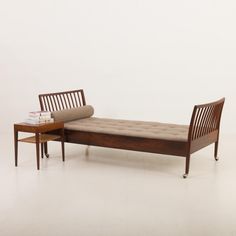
[{"x1": 188, "y1": 98, "x2": 225, "y2": 141}]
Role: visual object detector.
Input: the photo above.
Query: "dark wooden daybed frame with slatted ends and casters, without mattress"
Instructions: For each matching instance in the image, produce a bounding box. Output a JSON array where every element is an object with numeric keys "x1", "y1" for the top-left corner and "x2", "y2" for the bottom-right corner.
[{"x1": 39, "y1": 89, "x2": 225, "y2": 178}]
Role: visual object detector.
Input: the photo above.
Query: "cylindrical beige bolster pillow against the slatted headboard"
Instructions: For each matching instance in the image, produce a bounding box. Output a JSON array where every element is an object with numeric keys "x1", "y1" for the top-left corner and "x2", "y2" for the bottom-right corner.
[{"x1": 52, "y1": 105, "x2": 94, "y2": 122}]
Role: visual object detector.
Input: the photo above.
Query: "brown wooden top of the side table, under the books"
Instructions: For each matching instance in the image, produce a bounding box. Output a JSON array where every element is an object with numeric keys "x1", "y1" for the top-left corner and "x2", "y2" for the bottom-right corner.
[{"x1": 14, "y1": 121, "x2": 64, "y2": 133}]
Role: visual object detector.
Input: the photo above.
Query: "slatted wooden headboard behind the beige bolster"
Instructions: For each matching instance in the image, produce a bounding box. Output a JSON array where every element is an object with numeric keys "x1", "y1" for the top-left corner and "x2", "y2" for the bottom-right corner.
[{"x1": 39, "y1": 89, "x2": 86, "y2": 112}]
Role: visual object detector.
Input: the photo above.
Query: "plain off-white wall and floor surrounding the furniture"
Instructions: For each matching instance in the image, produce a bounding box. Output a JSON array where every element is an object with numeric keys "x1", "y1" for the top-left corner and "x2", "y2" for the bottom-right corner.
[{"x1": 0, "y1": 0, "x2": 236, "y2": 236}]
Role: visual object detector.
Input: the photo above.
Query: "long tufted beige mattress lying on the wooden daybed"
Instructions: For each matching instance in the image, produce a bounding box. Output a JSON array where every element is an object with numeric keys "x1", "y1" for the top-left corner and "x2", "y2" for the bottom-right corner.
[{"x1": 65, "y1": 117, "x2": 189, "y2": 141}]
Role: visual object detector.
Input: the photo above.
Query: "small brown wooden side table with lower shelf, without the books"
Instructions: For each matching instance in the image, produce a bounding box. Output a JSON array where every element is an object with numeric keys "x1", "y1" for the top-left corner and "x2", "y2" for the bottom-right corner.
[{"x1": 14, "y1": 122, "x2": 65, "y2": 170}]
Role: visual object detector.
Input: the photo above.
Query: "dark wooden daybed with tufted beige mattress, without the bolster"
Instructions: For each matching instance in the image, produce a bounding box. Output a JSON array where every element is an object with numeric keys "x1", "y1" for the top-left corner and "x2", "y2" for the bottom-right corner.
[{"x1": 39, "y1": 89, "x2": 225, "y2": 178}]
